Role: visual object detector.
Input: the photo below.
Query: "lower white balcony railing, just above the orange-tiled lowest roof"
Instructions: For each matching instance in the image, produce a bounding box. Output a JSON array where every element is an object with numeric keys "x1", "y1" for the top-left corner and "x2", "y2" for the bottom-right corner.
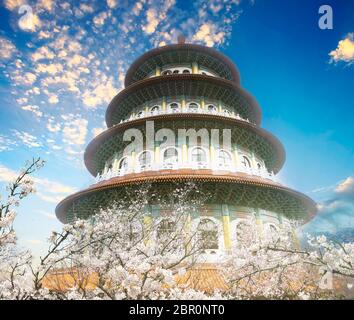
[{"x1": 94, "y1": 162, "x2": 276, "y2": 183}]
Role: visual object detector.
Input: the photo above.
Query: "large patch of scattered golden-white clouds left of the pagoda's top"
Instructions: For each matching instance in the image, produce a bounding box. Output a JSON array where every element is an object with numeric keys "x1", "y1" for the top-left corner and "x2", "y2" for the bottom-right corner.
[{"x1": 0, "y1": 0, "x2": 241, "y2": 165}]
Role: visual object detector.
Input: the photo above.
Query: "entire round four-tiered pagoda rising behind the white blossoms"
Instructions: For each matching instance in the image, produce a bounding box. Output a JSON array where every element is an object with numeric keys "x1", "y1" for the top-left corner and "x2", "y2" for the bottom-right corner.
[{"x1": 56, "y1": 37, "x2": 316, "y2": 253}]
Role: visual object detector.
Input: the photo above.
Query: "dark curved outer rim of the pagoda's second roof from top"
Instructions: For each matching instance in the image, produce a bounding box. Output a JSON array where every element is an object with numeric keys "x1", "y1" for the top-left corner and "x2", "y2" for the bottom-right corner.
[{"x1": 106, "y1": 74, "x2": 262, "y2": 127}]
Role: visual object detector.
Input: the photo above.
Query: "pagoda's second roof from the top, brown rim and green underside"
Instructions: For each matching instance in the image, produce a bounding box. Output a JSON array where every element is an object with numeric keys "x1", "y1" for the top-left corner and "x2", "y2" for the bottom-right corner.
[{"x1": 106, "y1": 74, "x2": 261, "y2": 127}]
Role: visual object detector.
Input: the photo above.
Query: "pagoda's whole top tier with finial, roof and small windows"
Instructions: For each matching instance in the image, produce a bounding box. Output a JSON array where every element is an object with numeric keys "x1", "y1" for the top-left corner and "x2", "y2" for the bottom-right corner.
[{"x1": 125, "y1": 42, "x2": 240, "y2": 87}]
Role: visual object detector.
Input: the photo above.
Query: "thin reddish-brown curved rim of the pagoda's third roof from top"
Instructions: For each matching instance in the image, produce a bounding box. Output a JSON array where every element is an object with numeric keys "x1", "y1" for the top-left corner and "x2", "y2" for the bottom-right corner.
[{"x1": 84, "y1": 113, "x2": 285, "y2": 176}]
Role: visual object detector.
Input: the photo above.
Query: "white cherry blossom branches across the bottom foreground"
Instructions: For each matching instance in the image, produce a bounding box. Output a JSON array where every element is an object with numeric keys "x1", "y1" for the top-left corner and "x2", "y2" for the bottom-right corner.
[{"x1": 0, "y1": 159, "x2": 354, "y2": 300}]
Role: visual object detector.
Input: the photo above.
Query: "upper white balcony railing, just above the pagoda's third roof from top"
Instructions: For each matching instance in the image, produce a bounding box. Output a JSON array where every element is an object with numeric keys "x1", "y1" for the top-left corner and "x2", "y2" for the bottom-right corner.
[{"x1": 119, "y1": 108, "x2": 250, "y2": 124}]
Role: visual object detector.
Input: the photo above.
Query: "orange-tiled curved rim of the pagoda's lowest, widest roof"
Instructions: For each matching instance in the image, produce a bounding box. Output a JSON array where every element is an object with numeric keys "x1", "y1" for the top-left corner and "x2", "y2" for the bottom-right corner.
[{"x1": 55, "y1": 170, "x2": 317, "y2": 223}]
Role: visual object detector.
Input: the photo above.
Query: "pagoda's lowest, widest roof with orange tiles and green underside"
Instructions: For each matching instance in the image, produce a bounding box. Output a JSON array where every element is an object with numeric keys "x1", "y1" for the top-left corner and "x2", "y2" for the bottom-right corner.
[{"x1": 56, "y1": 169, "x2": 317, "y2": 223}]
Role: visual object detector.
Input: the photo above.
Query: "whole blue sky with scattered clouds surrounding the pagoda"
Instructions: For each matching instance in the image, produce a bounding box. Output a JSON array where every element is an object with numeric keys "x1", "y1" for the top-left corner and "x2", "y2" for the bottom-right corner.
[{"x1": 0, "y1": 0, "x2": 354, "y2": 253}]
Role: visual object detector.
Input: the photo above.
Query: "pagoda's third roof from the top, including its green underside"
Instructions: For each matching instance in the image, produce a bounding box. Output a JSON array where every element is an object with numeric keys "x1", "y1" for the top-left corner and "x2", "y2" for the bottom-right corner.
[{"x1": 84, "y1": 113, "x2": 285, "y2": 176}]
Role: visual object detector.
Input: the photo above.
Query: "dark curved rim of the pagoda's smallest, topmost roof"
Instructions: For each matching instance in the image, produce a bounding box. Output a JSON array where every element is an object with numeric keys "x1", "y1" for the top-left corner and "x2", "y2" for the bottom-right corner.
[{"x1": 124, "y1": 43, "x2": 240, "y2": 87}]
